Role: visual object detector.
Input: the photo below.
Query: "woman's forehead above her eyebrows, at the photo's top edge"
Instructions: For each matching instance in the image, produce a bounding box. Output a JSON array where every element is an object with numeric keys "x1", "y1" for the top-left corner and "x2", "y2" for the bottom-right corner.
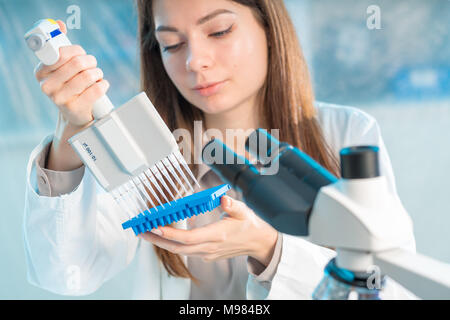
[{"x1": 152, "y1": 0, "x2": 243, "y2": 27}]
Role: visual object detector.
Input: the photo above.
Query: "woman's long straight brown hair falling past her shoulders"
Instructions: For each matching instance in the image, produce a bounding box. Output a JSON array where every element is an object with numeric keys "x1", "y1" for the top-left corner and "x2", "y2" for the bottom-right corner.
[{"x1": 137, "y1": 0, "x2": 339, "y2": 280}]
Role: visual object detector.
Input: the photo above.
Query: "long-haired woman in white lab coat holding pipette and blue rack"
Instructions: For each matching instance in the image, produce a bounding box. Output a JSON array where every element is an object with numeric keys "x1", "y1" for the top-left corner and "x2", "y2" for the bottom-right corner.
[{"x1": 25, "y1": 0, "x2": 415, "y2": 299}]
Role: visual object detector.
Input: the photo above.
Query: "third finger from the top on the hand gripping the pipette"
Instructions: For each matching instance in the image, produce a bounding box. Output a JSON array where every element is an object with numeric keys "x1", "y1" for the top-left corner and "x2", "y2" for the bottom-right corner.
[{"x1": 53, "y1": 68, "x2": 103, "y2": 105}]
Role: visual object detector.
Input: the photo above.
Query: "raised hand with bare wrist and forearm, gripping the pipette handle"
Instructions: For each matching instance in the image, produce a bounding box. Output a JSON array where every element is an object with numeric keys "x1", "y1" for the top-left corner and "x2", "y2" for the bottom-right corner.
[{"x1": 35, "y1": 20, "x2": 109, "y2": 171}]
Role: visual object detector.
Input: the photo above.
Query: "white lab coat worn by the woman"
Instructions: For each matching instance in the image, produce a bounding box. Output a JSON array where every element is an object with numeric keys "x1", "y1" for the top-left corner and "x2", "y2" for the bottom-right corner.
[{"x1": 23, "y1": 103, "x2": 415, "y2": 299}]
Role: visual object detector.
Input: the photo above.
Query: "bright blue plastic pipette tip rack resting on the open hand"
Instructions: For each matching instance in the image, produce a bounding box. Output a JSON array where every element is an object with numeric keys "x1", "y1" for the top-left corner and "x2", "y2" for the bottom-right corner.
[{"x1": 122, "y1": 184, "x2": 231, "y2": 235}]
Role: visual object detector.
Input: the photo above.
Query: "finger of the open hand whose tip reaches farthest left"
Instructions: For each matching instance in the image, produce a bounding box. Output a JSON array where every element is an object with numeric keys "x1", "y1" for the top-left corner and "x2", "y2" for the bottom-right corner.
[{"x1": 139, "y1": 232, "x2": 219, "y2": 256}]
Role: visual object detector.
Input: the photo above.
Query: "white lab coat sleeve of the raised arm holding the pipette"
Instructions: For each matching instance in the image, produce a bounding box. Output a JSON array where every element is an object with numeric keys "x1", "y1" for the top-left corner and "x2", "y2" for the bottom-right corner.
[{"x1": 23, "y1": 135, "x2": 138, "y2": 296}]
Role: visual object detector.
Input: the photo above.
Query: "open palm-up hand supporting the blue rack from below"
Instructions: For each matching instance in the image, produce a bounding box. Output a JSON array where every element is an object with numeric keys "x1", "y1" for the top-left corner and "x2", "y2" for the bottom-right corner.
[{"x1": 140, "y1": 196, "x2": 278, "y2": 266}]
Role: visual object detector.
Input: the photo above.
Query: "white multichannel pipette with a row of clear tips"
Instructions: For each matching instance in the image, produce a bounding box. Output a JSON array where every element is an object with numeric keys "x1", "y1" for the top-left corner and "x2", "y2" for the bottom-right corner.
[{"x1": 25, "y1": 19, "x2": 199, "y2": 218}]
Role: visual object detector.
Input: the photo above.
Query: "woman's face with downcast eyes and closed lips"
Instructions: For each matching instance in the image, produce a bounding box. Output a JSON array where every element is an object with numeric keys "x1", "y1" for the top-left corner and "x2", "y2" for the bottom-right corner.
[{"x1": 153, "y1": 0, "x2": 268, "y2": 114}]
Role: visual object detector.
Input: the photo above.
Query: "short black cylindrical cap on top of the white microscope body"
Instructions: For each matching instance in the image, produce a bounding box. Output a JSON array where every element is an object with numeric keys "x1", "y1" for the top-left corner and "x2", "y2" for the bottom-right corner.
[{"x1": 340, "y1": 146, "x2": 380, "y2": 179}]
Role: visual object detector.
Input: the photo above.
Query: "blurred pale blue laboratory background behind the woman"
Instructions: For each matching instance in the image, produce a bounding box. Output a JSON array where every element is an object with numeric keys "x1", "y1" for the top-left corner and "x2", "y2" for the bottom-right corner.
[{"x1": 0, "y1": 0, "x2": 450, "y2": 299}]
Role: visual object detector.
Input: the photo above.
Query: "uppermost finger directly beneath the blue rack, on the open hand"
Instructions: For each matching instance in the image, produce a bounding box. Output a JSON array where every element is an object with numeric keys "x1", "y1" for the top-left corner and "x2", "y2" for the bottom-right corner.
[{"x1": 158, "y1": 222, "x2": 226, "y2": 244}]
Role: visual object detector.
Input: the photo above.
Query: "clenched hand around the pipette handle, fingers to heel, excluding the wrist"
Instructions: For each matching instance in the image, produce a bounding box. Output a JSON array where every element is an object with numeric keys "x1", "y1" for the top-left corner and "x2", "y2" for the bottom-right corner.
[{"x1": 35, "y1": 20, "x2": 109, "y2": 129}]
